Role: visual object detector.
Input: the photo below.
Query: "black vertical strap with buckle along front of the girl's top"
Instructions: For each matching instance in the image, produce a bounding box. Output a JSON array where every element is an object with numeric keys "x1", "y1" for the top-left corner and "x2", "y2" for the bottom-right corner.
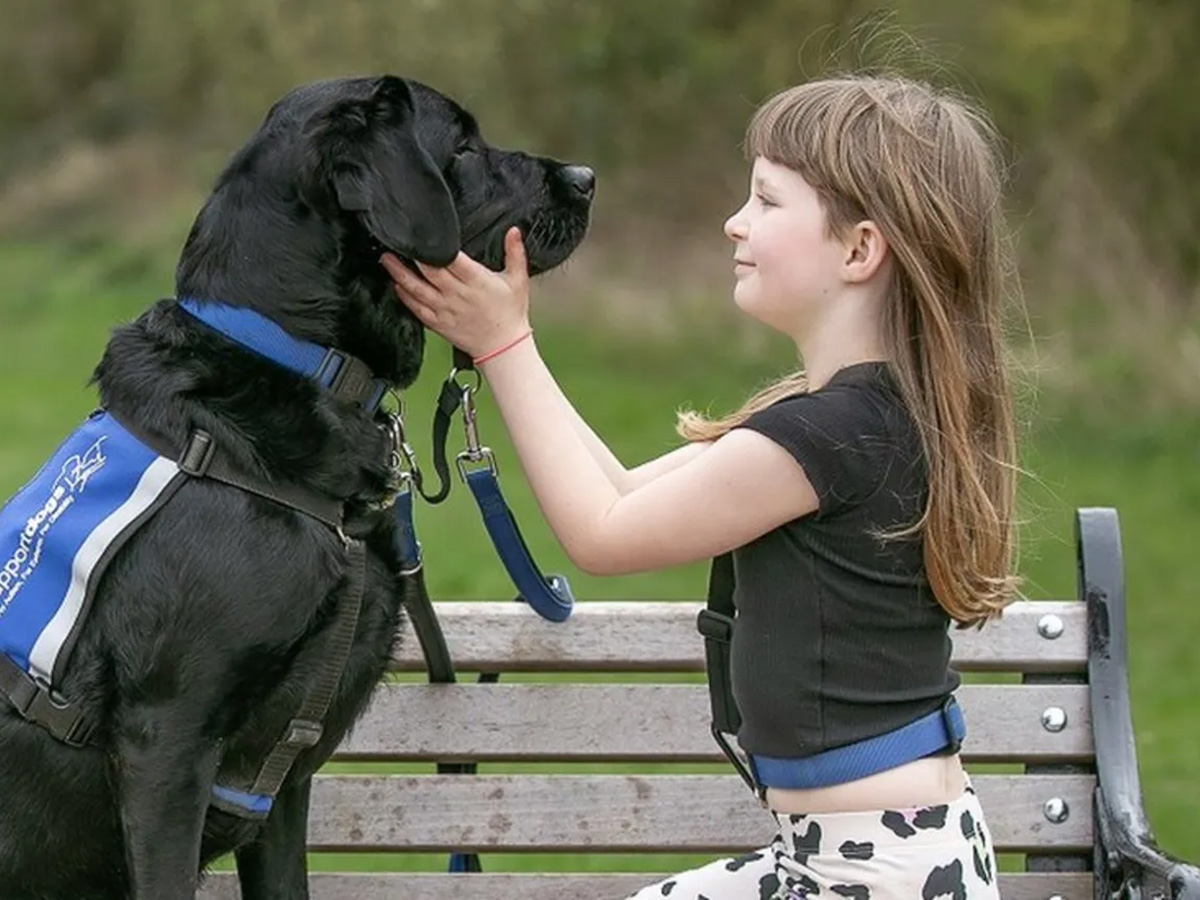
[{"x1": 696, "y1": 553, "x2": 761, "y2": 794}]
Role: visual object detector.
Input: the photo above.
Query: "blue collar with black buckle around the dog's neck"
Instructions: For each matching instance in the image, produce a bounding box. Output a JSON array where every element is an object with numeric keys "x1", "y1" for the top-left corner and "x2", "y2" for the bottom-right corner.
[{"x1": 179, "y1": 296, "x2": 389, "y2": 413}]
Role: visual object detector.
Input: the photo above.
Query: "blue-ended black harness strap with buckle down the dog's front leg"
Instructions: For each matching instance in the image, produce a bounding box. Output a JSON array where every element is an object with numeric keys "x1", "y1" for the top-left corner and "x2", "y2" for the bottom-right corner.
[{"x1": 212, "y1": 539, "x2": 366, "y2": 817}]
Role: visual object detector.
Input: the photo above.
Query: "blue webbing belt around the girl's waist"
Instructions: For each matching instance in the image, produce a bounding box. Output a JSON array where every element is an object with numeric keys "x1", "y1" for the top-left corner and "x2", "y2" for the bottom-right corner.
[{"x1": 750, "y1": 697, "x2": 967, "y2": 790}]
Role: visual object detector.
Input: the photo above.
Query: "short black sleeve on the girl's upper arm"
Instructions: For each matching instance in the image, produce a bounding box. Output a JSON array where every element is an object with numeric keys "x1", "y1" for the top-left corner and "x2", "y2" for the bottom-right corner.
[{"x1": 738, "y1": 384, "x2": 888, "y2": 517}]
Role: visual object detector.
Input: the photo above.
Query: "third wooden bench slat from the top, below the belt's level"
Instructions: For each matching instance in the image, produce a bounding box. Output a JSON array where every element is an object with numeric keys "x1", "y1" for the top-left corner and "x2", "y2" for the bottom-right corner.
[{"x1": 308, "y1": 775, "x2": 1096, "y2": 853}]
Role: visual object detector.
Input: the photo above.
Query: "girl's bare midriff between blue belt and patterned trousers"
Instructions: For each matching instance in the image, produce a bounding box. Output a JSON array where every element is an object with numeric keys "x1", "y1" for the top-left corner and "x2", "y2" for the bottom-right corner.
[{"x1": 767, "y1": 754, "x2": 966, "y2": 814}]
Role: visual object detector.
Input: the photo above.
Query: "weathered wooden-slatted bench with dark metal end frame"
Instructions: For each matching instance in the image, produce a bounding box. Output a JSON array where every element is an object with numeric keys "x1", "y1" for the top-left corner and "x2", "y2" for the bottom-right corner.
[{"x1": 202, "y1": 510, "x2": 1200, "y2": 900}]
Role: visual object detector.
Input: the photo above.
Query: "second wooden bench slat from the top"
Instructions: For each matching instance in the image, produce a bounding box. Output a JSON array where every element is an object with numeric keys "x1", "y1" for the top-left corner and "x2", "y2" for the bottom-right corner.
[{"x1": 337, "y1": 683, "x2": 1093, "y2": 762}]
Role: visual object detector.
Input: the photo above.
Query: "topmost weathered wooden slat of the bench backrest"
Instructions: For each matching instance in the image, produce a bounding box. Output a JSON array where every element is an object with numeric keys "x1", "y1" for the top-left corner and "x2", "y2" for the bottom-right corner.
[{"x1": 394, "y1": 600, "x2": 1087, "y2": 672}]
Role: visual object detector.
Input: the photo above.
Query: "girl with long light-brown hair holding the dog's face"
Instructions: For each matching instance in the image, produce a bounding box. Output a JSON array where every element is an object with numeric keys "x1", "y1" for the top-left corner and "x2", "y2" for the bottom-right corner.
[{"x1": 384, "y1": 77, "x2": 1015, "y2": 900}]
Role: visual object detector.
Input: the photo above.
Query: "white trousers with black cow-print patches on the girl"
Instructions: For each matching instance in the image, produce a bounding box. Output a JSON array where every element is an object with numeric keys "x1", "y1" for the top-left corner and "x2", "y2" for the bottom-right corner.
[{"x1": 629, "y1": 784, "x2": 1000, "y2": 900}]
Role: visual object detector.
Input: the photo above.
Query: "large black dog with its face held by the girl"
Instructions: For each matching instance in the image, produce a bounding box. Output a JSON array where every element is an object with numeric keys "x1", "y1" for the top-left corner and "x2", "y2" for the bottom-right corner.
[{"x1": 0, "y1": 76, "x2": 594, "y2": 900}]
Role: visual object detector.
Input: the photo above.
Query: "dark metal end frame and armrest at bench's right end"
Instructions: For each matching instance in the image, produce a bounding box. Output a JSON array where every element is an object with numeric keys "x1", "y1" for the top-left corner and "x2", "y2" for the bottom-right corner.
[{"x1": 1075, "y1": 509, "x2": 1200, "y2": 900}]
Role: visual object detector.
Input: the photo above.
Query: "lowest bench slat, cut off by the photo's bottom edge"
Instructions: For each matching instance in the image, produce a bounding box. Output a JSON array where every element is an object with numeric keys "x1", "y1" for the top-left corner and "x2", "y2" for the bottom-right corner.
[{"x1": 198, "y1": 872, "x2": 1092, "y2": 900}]
